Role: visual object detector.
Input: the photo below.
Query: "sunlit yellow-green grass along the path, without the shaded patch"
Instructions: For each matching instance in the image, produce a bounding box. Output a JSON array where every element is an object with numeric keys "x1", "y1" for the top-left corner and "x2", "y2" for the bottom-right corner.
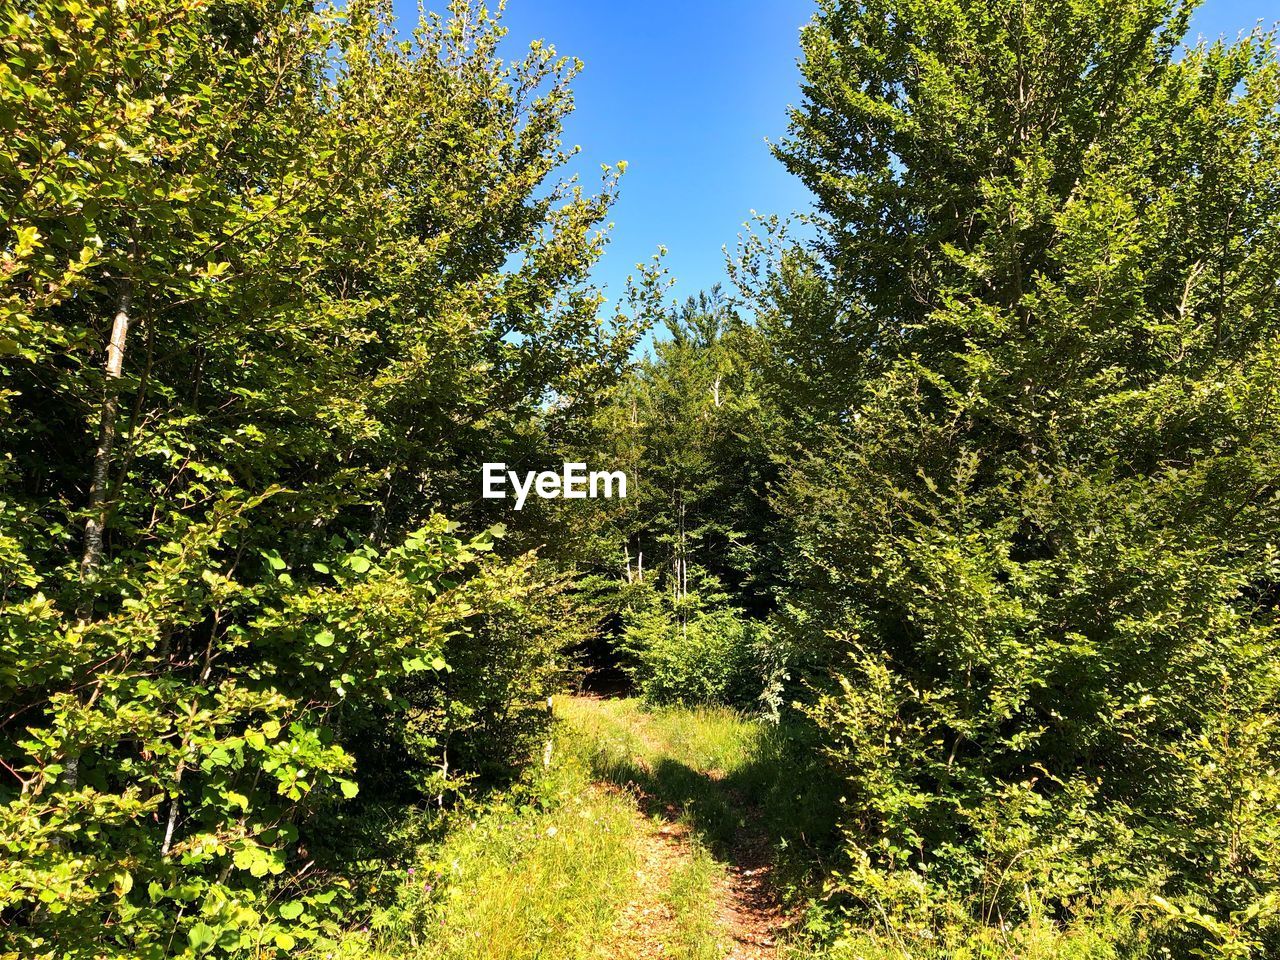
[{"x1": 337, "y1": 701, "x2": 759, "y2": 960}]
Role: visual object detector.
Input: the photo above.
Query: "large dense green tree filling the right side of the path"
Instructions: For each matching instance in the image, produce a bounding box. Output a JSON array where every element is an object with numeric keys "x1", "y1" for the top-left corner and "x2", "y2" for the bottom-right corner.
[{"x1": 742, "y1": 0, "x2": 1280, "y2": 956}]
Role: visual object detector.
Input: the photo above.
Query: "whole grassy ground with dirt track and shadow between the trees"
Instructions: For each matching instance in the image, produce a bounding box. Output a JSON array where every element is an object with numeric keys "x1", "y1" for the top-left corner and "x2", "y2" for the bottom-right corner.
[{"x1": 340, "y1": 696, "x2": 804, "y2": 960}]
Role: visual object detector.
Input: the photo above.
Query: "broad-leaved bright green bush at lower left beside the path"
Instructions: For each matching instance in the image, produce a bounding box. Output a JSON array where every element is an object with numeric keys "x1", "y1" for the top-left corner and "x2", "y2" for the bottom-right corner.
[{"x1": 0, "y1": 514, "x2": 548, "y2": 957}]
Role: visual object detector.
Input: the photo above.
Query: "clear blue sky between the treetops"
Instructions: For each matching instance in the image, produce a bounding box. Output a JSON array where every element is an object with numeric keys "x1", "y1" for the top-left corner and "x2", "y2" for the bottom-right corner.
[{"x1": 396, "y1": 0, "x2": 1280, "y2": 308}]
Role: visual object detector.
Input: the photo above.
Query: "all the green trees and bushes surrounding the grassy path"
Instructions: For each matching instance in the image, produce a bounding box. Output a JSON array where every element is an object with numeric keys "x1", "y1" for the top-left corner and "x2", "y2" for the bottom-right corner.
[{"x1": 0, "y1": 0, "x2": 1280, "y2": 960}]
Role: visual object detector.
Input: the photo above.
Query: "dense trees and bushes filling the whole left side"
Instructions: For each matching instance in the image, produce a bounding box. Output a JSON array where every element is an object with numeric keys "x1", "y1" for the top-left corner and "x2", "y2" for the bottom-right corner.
[{"x1": 0, "y1": 0, "x2": 634, "y2": 957}]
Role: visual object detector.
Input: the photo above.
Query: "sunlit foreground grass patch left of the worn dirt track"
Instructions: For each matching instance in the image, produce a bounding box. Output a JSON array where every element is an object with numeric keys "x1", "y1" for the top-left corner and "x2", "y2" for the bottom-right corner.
[{"x1": 343, "y1": 763, "x2": 640, "y2": 960}]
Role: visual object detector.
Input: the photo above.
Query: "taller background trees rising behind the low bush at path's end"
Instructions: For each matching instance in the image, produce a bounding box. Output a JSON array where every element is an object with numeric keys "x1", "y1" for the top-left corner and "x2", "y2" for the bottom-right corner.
[{"x1": 571, "y1": 288, "x2": 776, "y2": 628}]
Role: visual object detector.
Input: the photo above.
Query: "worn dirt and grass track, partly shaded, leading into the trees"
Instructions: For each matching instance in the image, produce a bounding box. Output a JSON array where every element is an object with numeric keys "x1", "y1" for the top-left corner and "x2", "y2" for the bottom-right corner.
[{"x1": 557, "y1": 698, "x2": 788, "y2": 960}]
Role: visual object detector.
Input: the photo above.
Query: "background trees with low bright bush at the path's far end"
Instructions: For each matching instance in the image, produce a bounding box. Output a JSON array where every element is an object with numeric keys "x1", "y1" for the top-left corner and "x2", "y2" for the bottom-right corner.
[{"x1": 563, "y1": 287, "x2": 777, "y2": 705}]
